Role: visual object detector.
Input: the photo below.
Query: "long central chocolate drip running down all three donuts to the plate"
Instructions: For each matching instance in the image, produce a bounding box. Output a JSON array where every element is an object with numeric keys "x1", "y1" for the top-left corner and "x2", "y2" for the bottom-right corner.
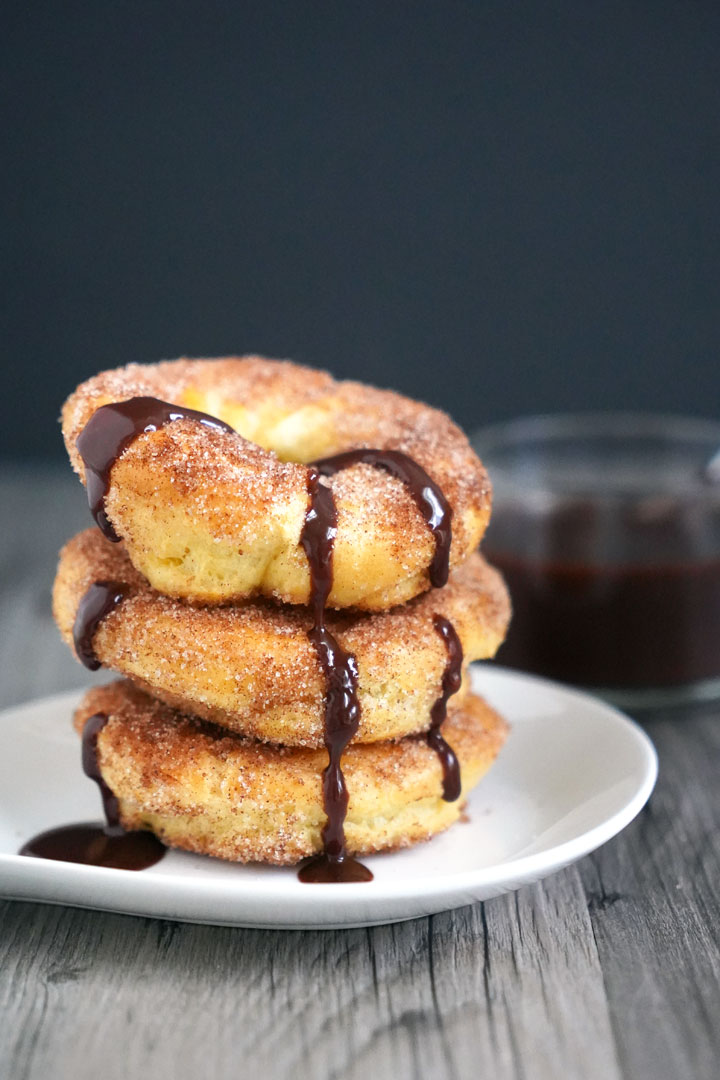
[{"x1": 298, "y1": 467, "x2": 372, "y2": 883}]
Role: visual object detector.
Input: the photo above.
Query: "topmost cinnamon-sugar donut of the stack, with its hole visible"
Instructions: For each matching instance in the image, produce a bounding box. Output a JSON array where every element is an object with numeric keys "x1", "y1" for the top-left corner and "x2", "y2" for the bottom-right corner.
[{"x1": 63, "y1": 356, "x2": 490, "y2": 610}]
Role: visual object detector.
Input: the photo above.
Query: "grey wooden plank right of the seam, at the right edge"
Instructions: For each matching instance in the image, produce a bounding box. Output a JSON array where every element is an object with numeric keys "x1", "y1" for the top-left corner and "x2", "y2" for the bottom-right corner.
[{"x1": 580, "y1": 707, "x2": 720, "y2": 1077}]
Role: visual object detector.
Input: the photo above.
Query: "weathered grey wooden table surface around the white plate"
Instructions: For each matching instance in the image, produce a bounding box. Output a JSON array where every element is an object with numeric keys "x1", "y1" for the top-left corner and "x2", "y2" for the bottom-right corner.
[{"x1": 0, "y1": 467, "x2": 720, "y2": 1080}]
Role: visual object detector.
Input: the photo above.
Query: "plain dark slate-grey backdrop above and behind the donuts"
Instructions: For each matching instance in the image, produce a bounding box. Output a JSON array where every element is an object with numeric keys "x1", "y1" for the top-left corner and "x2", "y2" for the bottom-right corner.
[{"x1": 0, "y1": 0, "x2": 720, "y2": 457}]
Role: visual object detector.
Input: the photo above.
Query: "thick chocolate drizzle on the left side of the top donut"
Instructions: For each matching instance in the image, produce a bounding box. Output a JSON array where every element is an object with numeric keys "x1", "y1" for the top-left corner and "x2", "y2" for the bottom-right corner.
[{"x1": 76, "y1": 397, "x2": 233, "y2": 543}]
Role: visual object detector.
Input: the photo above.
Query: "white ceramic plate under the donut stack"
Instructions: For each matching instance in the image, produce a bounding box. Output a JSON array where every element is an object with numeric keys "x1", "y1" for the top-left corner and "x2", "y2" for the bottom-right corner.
[{"x1": 0, "y1": 665, "x2": 657, "y2": 929}]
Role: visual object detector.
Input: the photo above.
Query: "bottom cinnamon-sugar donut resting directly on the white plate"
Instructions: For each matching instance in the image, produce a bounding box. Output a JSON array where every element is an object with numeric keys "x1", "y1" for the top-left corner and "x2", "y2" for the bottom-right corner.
[{"x1": 74, "y1": 681, "x2": 506, "y2": 864}]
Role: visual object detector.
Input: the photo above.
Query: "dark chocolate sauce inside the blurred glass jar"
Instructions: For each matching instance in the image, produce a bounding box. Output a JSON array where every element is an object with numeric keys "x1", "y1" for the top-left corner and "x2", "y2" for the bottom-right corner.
[{"x1": 484, "y1": 500, "x2": 720, "y2": 691}]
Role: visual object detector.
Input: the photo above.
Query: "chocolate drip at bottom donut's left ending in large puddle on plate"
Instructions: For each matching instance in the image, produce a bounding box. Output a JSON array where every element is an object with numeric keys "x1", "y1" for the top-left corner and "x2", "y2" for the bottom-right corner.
[{"x1": 19, "y1": 713, "x2": 166, "y2": 870}]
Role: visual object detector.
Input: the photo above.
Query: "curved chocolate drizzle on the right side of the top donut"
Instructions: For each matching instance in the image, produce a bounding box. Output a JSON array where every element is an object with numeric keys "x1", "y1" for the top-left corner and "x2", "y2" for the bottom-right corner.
[{"x1": 314, "y1": 449, "x2": 452, "y2": 589}]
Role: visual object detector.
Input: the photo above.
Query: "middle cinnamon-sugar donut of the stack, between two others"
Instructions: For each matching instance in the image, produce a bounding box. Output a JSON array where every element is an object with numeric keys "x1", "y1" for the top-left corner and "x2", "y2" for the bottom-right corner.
[{"x1": 53, "y1": 529, "x2": 510, "y2": 746}]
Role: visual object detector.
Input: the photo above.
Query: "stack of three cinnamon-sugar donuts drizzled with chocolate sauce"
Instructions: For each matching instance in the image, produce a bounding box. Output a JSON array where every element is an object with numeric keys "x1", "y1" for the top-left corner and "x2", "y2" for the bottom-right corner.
[{"x1": 54, "y1": 356, "x2": 510, "y2": 880}]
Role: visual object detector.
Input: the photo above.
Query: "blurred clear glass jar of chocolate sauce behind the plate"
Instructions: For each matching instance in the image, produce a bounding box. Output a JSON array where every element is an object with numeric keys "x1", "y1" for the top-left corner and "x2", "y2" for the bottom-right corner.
[{"x1": 473, "y1": 414, "x2": 720, "y2": 707}]
